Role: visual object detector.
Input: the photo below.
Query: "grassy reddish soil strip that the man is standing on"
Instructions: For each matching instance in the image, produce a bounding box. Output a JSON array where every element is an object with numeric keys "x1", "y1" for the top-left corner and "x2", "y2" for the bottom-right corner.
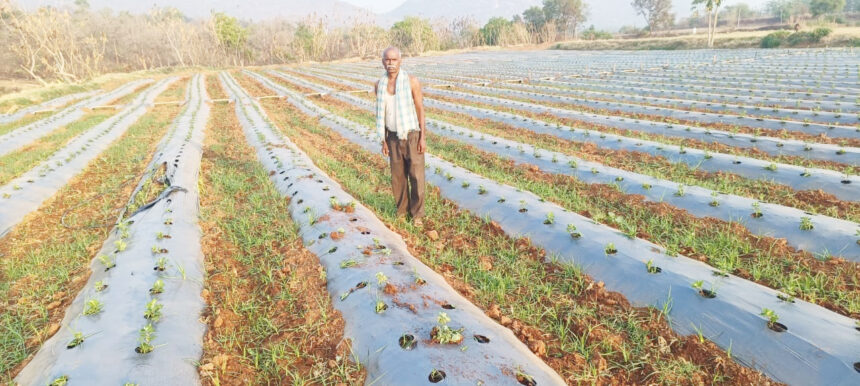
[{"x1": 235, "y1": 72, "x2": 780, "y2": 384}]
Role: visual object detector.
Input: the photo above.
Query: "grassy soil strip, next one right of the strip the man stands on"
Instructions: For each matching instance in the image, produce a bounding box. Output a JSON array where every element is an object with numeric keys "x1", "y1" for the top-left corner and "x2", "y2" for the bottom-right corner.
[{"x1": 262, "y1": 69, "x2": 860, "y2": 322}]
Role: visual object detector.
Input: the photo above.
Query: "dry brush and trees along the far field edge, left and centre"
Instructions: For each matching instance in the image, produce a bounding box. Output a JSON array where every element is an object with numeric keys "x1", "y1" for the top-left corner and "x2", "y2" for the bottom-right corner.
[{"x1": 0, "y1": 0, "x2": 587, "y2": 84}]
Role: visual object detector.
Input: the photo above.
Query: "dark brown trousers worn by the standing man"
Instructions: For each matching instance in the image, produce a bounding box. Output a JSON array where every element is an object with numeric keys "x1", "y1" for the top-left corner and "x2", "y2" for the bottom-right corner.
[{"x1": 385, "y1": 129, "x2": 424, "y2": 218}]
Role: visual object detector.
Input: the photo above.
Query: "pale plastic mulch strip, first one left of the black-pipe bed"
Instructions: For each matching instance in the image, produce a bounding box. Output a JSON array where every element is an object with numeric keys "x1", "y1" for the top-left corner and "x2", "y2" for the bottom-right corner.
[{"x1": 0, "y1": 77, "x2": 177, "y2": 237}]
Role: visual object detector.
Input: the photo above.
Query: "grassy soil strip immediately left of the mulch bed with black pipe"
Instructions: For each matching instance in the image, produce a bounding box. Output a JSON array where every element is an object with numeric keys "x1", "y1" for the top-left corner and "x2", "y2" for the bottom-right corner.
[{"x1": 0, "y1": 90, "x2": 179, "y2": 383}]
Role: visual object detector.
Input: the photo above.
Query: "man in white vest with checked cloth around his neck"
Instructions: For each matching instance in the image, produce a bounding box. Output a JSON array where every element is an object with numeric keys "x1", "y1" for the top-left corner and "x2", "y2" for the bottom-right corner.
[{"x1": 374, "y1": 47, "x2": 427, "y2": 227}]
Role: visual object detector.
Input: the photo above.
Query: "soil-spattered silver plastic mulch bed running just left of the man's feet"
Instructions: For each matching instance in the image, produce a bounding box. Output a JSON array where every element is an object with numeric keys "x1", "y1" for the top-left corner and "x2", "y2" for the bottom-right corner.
[{"x1": 222, "y1": 73, "x2": 564, "y2": 385}]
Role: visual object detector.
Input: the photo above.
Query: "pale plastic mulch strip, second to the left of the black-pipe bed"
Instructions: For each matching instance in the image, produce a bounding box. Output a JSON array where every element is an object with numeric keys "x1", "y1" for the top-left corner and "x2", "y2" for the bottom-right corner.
[{"x1": 0, "y1": 79, "x2": 152, "y2": 156}]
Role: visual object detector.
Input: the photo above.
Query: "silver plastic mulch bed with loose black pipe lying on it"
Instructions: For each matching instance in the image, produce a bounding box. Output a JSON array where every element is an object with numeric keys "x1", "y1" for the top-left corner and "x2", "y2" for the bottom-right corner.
[{"x1": 15, "y1": 74, "x2": 209, "y2": 385}]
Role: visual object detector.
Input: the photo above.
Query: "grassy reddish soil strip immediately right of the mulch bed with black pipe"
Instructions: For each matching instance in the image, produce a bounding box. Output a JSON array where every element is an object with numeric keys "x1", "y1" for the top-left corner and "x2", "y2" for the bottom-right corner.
[{"x1": 198, "y1": 76, "x2": 364, "y2": 385}]
